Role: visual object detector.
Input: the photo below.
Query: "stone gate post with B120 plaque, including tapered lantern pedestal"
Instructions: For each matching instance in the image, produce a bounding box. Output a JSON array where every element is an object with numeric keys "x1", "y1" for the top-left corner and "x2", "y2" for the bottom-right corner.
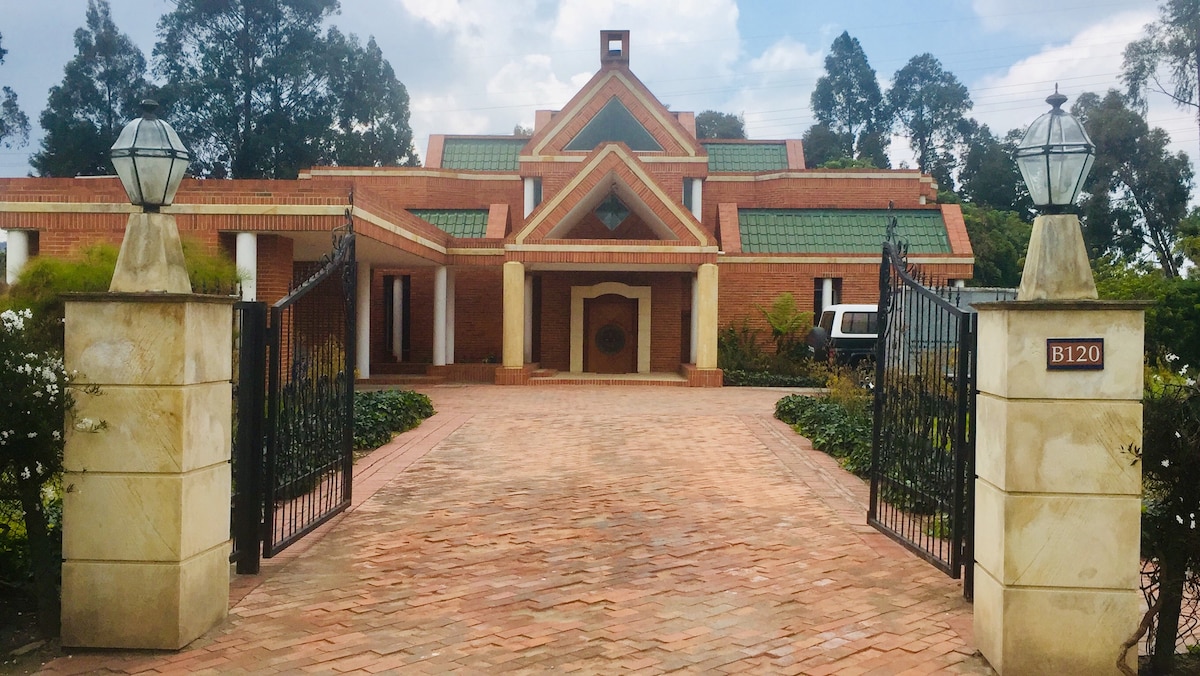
[{"x1": 974, "y1": 216, "x2": 1145, "y2": 675}]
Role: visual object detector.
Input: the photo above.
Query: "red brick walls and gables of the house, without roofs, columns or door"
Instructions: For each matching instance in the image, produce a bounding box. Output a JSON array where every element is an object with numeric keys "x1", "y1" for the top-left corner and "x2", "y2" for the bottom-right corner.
[{"x1": 0, "y1": 31, "x2": 973, "y2": 387}]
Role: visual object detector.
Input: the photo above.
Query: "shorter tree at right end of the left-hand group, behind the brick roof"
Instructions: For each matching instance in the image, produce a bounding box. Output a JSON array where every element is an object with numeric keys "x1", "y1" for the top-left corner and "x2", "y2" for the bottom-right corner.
[{"x1": 329, "y1": 29, "x2": 420, "y2": 167}]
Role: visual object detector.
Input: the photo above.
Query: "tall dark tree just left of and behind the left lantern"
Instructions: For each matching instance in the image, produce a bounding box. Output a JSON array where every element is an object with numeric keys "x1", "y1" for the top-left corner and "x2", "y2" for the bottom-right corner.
[{"x1": 30, "y1": 0, "x2": 150, "y2": 177}]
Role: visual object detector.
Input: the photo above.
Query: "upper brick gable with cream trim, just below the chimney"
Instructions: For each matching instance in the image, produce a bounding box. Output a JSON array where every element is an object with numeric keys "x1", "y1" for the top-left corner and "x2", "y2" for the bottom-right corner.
[{"x1": 522, "y1": 68, "x2": 704, "y2": 157}]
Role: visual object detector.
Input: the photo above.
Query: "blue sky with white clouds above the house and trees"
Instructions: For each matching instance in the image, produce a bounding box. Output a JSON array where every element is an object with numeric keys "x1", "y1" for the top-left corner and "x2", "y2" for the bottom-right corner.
[{"x1": 0, "y1": 0, "x2": 1185, "y2": 183}]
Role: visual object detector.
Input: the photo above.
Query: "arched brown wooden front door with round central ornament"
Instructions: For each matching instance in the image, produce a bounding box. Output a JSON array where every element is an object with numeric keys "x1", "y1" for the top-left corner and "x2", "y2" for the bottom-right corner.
[{"x1": 583, "y1": 293, "x2": 637, "y2": 373}]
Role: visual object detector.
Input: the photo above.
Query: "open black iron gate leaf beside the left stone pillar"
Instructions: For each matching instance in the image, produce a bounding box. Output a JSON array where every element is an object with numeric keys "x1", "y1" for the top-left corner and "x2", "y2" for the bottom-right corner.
[{"x1": 232, "y1": 216, "x2": 356, "y2": 574}]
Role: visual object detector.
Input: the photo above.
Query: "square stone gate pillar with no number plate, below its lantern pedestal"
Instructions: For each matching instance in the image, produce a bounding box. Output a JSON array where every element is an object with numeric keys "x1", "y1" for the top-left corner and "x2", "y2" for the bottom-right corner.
[{"x1": 62, "y1": 293, "x2": 233, "y2": 650}]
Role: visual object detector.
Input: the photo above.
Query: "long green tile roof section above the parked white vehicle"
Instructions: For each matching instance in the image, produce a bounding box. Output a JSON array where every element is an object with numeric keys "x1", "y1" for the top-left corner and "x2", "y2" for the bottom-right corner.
[{"x1": 738, "y1": 209, "x2": 950, "y2": 253}]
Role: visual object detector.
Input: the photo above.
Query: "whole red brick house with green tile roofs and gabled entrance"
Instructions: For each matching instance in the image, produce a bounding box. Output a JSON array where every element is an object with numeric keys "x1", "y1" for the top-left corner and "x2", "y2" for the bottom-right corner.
[{"x1": 0, "y1": 30, "x2": 973, "y2": 385}]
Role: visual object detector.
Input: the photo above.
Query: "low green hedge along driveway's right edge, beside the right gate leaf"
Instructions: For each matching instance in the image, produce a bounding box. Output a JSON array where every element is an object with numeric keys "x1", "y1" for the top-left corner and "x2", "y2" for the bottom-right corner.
[{"x1": 775, "y1": 394, "x2": 871, "y2": 478}]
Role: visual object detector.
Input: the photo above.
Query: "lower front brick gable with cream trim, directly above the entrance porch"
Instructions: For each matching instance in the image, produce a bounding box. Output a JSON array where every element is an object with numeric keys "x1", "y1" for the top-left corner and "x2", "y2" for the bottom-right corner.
[{"x1": 516, "y1": 144, "x2": 713, "y2": 246}]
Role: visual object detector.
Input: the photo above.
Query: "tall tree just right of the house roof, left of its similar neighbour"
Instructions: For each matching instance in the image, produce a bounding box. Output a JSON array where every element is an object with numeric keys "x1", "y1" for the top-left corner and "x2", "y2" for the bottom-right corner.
[{"x1": 811, "y1": 31, "x2": 888, "y2": 166}]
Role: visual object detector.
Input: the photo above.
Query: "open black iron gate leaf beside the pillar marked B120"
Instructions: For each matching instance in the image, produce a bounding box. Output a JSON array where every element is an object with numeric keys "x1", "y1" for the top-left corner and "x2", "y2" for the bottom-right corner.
[{"x1": 868, "y1": 240, "x2": 976, "y2": 598}]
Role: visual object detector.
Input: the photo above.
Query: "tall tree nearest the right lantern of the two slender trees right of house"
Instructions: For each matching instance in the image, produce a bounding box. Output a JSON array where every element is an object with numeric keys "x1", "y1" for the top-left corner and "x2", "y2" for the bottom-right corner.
[{"x1": 887, "y1": 53, "x2": 972, "y2": 190}]
